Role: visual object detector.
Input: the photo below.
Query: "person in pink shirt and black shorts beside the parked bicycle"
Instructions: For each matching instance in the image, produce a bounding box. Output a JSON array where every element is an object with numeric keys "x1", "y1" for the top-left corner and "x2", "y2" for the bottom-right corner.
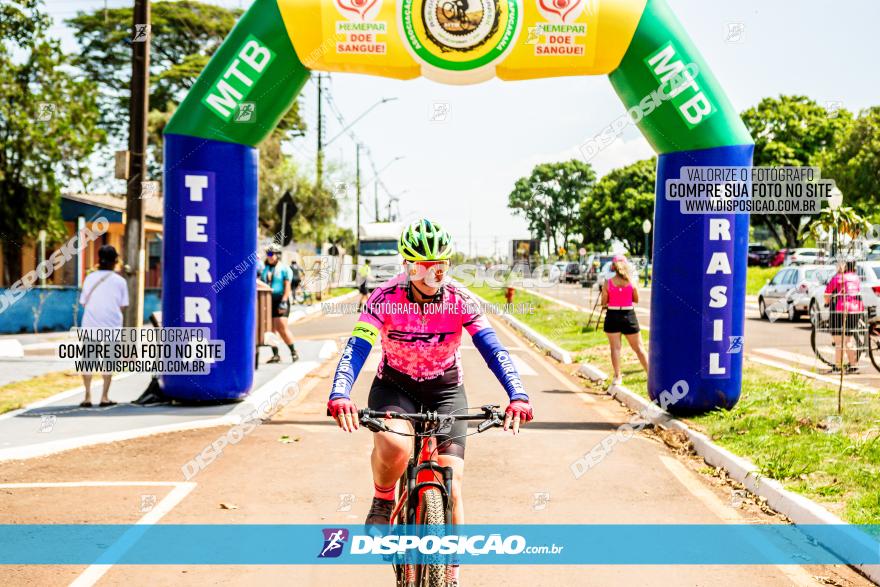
[{"x1": 825, "y1": 258, "x2": 865, "y2": 373}]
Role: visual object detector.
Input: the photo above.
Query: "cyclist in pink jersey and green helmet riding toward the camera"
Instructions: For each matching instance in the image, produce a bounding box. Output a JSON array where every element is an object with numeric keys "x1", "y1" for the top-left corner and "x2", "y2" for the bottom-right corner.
[{"x1": 327, "y1": 219, "x2": 532, "y2": 584}]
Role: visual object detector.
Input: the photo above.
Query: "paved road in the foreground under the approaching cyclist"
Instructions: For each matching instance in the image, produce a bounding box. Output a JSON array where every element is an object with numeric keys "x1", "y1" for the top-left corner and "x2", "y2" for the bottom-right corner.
[{"x1": 0, "y1": 316, "x2": 867, "y2": 587}]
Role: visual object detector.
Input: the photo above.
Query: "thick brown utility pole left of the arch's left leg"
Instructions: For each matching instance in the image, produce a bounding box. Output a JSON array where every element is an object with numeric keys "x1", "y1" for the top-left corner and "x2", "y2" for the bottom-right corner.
[{"x1": 123, "y1": 0, "x2": 150, "y2": 326}]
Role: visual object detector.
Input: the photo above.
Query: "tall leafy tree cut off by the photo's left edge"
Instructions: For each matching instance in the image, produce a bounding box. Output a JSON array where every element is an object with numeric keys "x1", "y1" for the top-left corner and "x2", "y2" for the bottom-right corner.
[{"x1": 0, "y1": 0, "x2": 105, "y2": 283}]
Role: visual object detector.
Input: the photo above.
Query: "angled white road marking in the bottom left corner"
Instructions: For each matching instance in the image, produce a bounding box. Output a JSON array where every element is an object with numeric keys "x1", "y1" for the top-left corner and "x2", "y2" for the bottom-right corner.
[{"x1": 0, "y1": 481, "x2": 196, "y2": 587}]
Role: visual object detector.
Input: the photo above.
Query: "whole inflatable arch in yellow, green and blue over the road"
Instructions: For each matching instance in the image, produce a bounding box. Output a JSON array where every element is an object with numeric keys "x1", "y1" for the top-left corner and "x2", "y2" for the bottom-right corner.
[{"x1": 162, "y1": 0, "x2": 753, "y2": 413}]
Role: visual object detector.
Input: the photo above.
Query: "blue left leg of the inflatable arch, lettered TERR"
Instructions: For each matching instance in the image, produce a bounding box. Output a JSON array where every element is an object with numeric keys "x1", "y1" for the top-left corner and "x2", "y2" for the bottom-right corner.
[{"x1": 161, "y1": 135, "x2": 257, "y2": 402}]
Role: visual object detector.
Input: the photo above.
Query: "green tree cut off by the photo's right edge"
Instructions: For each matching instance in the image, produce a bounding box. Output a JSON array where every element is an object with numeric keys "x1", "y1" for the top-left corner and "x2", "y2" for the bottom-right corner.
[{"x1": 823, "y1": 106, "x2": 880, "y2": 222}]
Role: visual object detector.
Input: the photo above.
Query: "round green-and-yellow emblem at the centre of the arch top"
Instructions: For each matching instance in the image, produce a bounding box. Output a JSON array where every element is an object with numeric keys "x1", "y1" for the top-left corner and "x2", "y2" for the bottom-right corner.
[{"x1": 400, "y1": 0, "x2": 521, "y2": 71}]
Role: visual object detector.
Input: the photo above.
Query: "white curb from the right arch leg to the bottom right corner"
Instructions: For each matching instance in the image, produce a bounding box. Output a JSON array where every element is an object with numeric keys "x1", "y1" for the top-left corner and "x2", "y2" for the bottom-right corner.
[{"x1": 608, "y1": 385, "x2": 880, "y2": 583}]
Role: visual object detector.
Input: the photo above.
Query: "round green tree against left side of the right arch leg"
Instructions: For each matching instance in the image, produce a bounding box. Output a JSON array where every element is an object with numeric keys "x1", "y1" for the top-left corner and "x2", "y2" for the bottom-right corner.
[{"x1": 580, "y1": 158, "x2": 657, "y2": 255}]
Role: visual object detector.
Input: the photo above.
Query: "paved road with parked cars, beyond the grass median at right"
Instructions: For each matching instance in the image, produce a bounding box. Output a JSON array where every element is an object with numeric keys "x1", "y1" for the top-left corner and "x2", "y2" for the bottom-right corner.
[{"x1": 534, "y1": 284, "x2": 880, "y2": 390}]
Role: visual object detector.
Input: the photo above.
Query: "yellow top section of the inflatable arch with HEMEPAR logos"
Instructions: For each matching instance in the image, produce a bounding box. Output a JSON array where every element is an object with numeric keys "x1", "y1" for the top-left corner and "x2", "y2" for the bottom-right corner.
[{"x1": 277, "y1": 0, "x2": 647, "y2": 84}]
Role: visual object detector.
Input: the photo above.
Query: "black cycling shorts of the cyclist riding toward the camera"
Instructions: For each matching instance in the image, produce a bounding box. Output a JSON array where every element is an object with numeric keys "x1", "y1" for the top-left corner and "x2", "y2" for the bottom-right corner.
[{"x1": 367, "y1": 364, "x2": 468, "y2": 458}]
